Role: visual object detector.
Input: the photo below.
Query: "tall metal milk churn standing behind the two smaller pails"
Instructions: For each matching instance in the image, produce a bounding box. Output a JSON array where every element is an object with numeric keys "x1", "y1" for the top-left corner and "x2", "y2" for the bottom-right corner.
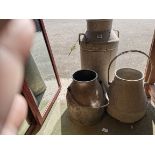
[{"x1": 79, "y1": 19, "x2": 119, "y2": 89}]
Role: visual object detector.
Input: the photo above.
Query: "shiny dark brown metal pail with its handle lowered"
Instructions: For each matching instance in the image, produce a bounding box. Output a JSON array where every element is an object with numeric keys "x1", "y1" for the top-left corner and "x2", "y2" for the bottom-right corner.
[{"x1": 66, "y1": 70, "x2": 108, "y2": 125}]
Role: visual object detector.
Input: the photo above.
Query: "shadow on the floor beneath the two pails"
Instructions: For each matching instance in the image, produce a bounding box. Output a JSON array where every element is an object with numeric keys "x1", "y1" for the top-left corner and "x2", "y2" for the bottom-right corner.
[{"x1": 52, "y1": 104, "x2": 155, "y2": 135}]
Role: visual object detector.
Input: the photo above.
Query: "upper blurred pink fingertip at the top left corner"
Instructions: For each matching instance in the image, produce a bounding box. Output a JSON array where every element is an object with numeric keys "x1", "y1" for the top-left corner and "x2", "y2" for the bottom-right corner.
[{"x1": 0, "y1": 19, "x2": 35, "y2": 61}]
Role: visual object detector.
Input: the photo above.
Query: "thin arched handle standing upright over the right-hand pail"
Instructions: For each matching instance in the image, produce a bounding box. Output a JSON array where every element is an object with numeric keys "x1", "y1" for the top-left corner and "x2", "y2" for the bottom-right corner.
[{"x1": 108, "y1": 50, "x2": 152, "y2": 84}]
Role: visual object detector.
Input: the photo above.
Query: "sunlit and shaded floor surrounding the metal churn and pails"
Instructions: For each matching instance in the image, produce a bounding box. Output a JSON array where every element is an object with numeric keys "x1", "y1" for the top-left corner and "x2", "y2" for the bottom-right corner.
[{"x1": 19, "y1": 20, "x2": 155, "y2": 135}]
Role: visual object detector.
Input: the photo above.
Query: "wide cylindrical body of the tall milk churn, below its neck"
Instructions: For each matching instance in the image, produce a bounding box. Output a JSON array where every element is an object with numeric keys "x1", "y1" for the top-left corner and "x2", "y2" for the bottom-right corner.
[{"x1": 80, "y1": 26, "x2": 119, "y2": 89}]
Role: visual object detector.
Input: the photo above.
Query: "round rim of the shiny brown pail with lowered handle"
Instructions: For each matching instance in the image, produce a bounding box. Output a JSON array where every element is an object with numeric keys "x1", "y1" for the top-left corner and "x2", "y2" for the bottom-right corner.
[{"x1": 72, "y1": 69, "x2": 98, "y2": 83}]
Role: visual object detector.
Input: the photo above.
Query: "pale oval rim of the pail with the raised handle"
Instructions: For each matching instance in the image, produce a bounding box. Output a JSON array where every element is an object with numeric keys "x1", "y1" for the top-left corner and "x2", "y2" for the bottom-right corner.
[{"x1": 115, "y1": 68, "x2": 144, "y2": 82}]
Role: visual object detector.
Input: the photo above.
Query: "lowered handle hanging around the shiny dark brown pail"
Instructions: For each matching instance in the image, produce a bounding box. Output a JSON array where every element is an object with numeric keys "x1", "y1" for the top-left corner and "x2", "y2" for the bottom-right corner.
[{"x1": 67, "y1": 81, "x2": 109, "y2": 109}]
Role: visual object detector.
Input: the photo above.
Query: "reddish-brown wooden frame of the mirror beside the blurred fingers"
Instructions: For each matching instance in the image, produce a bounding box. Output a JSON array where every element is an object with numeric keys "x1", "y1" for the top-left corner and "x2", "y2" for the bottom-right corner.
[{"x1": 22, "y1": 19, "x2": 61, "y2": 135}]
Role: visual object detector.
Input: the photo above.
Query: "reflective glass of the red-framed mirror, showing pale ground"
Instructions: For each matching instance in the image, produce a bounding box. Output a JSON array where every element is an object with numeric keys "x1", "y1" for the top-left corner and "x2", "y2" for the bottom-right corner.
[{"x1": 25, "y1": 20, "x2": 58, "y2": 116}]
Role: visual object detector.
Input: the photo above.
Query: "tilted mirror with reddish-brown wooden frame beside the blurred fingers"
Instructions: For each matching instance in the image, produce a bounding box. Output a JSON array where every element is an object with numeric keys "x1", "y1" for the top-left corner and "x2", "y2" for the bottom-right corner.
[{"x1": 18, "y1": 19, "x2": 61, "y2": 134}]
